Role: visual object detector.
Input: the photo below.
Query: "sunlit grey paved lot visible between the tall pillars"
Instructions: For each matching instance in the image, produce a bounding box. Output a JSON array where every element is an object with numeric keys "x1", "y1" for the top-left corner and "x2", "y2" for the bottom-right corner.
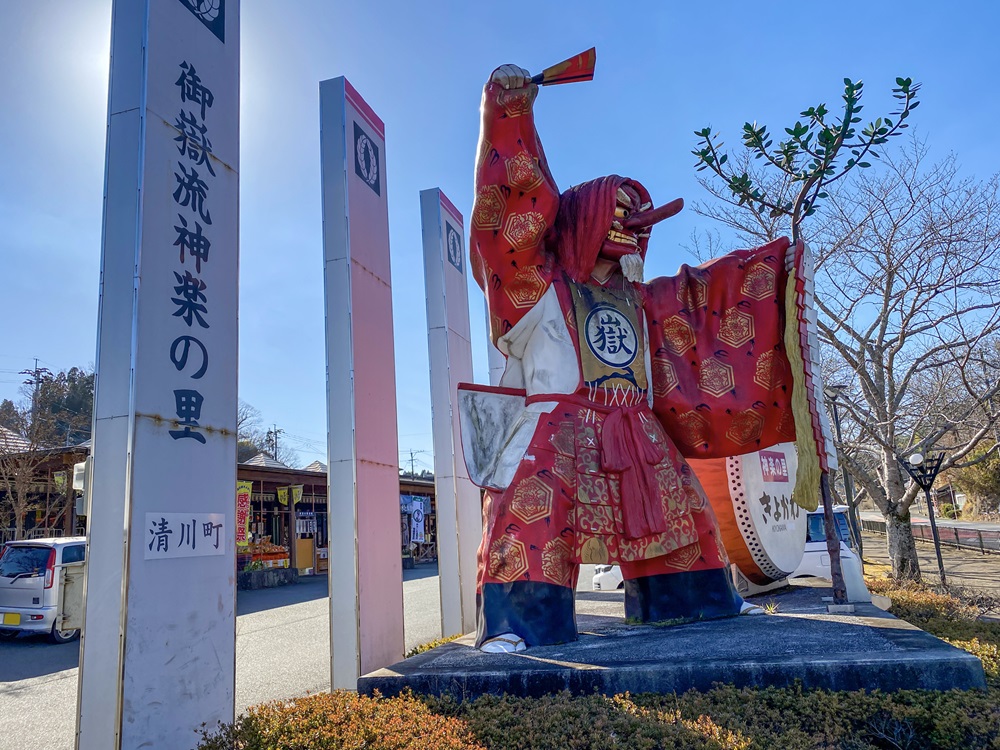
[{"x1": 0, "y1": 565, "x2": 441, "y2": 750}]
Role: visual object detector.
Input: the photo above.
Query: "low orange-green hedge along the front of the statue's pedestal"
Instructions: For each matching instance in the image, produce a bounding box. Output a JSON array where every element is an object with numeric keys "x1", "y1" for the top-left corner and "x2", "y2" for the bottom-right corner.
[{"x1": 198, "y1": 579, "x2": 1000, "y2": 750}]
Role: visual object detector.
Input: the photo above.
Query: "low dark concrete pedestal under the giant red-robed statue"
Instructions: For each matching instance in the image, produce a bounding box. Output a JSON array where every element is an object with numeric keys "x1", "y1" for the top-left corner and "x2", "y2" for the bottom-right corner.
[{"x1": 358, "y1": 579, "x2": 985, "y2": 698}]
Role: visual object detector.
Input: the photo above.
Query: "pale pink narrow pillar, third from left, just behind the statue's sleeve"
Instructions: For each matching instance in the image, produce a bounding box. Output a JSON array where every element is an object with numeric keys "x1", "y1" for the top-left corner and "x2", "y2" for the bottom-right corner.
[{"x1": 420, "y1": 188, "x2": 482, "y2": 634}]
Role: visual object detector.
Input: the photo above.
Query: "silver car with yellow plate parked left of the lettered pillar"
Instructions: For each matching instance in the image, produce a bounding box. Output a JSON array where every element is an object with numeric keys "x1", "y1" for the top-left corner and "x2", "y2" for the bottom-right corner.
[{"x1": 0, "y1": 537, "x2": 86, "y2": 643}]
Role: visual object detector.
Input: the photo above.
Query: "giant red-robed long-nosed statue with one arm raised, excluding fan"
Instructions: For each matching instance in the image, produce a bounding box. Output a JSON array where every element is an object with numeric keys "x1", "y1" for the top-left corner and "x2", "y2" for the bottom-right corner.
[{"x1": 463, "y1": 65, "x2": 817, "y2": 651}]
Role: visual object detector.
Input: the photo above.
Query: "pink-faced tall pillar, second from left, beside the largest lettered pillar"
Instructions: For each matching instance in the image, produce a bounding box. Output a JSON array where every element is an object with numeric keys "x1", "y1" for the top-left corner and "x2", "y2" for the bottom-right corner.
[{"x1": 319, "y1": 77, "x2": 404, "y2": 690}]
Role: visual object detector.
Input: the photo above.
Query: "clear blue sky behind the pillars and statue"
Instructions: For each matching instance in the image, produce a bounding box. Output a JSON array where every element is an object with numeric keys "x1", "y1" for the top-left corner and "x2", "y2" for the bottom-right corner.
[{"x1": 0, "y1": 0, "x2": 1000, "y2": 469}]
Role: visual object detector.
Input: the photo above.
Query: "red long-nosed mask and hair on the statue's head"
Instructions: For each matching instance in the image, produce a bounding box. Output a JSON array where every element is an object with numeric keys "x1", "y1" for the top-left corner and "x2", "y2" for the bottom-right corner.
[{"x1": 549, "y1": 175, "x2": 684, "y2": 283}]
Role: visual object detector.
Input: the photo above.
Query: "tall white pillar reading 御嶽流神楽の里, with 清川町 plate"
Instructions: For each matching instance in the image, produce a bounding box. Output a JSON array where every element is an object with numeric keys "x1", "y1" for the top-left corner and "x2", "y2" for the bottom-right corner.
[{"x1": 79, "y1": 0, "x2": 238, "y2": 750}]
